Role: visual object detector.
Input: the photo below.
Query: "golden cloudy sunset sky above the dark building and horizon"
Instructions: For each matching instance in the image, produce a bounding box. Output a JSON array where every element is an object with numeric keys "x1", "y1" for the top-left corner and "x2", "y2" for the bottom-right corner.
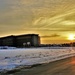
[{"x1": 0, "y1": 0, "x2": 75, "y2": 44}]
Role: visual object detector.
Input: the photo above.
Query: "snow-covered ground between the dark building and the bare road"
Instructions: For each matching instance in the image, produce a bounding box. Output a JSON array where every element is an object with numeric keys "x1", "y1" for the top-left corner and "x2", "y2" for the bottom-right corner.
[{"x1": 0, "y1": 47, "x2": 75, "y2": 71}]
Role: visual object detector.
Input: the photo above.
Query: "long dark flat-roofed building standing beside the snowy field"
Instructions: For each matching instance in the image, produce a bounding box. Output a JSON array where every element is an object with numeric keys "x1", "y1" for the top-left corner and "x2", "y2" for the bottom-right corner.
[{"x1": 0, "y1": 34, "x2": 40, "y2": 47}]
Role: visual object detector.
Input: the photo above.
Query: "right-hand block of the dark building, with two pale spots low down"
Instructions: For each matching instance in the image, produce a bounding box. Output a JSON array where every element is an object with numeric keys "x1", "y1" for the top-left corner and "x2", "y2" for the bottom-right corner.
[{"x1": 17, "y1": 34, "x2": 40, "y2": 47}]
